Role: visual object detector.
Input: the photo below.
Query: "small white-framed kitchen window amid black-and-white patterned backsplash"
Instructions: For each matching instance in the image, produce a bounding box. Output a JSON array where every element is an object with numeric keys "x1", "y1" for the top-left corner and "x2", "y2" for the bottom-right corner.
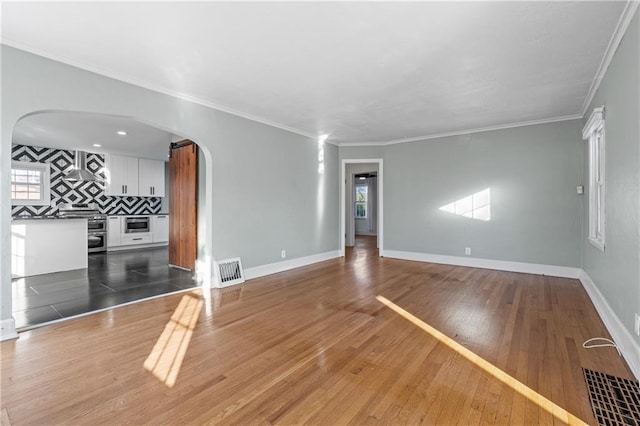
[{"x1": 11, "y1": 161, "x2": 51, "y2": 206}]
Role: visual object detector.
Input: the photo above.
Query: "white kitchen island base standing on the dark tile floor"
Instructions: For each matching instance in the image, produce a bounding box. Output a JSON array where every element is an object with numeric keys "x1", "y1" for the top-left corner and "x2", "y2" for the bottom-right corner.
[{"x1": 11, "y1": 217, "x2": 88, "y2": 277}]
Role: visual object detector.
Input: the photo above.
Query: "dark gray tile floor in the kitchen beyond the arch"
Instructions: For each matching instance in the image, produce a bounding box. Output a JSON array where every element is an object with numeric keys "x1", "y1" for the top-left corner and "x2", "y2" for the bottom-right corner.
[{"x1": 12, "y1": 247, "x2": 198, "y2": 329}]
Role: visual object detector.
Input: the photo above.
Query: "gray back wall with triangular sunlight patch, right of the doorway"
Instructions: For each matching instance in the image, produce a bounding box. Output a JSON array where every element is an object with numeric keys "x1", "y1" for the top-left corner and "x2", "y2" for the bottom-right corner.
[{"x1": 340, "y1": 120, "x2": 582, "y2": 267}]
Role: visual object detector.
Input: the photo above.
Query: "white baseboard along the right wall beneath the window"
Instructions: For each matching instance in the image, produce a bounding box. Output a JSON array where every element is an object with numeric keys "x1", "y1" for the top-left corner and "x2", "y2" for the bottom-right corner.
[{"x1": 580, "y1": 271, "x2": 640, "y2": 380}]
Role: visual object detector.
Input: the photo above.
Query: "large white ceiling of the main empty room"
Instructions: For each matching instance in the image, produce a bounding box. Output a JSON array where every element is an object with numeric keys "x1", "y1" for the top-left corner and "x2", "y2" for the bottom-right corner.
[{"x1": 2, "y1": 1, "x2": 626, "y2": 143}]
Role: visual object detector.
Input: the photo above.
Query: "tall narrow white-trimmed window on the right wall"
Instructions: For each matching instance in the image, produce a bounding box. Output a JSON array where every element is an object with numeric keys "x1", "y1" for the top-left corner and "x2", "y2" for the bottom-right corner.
[{"x1": 582, "y1": 107, "x2": 605, "y2": 251}]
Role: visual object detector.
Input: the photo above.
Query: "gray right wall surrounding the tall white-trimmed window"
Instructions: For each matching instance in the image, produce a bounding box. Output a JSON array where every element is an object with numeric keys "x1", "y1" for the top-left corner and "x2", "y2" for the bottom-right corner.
[{"x1": 582, "y1": 12, "x2": 640, "y2": 344}]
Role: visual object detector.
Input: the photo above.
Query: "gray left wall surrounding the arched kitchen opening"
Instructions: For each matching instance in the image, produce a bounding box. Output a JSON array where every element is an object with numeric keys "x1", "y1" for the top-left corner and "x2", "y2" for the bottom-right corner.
[{"x1": 0, "y1": 45, "x2": 338, "y2": 319}]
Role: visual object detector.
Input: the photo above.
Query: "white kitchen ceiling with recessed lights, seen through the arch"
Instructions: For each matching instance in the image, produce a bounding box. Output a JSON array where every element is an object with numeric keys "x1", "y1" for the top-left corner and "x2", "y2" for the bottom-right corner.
[{"x1": 12, "y1": 112, "x2": 173, "y2": 161}]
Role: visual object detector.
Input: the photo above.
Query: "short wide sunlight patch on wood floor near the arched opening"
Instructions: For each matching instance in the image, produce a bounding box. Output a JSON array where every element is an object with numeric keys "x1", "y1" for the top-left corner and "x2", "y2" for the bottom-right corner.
[{"x1": 144, "y1": 290, "x2": 203, "y2": 388}]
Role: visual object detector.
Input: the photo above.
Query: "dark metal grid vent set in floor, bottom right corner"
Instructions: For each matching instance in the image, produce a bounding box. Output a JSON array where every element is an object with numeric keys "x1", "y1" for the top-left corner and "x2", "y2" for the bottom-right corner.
[{"x1": 582, "y1": 368, "x2": 640, "y2": 426}]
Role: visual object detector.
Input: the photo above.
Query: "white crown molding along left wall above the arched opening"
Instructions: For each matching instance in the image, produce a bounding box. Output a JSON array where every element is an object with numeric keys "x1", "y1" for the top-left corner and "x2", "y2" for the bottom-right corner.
[{"x1": 0, "y1": 38, "x2": 320, "y2": 144}]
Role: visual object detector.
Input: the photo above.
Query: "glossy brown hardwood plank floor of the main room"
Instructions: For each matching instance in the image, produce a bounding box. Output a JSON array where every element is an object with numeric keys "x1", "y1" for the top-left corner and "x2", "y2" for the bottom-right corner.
[{"x1": 1, "y1": 238, "x2": 632, "y2": 425}]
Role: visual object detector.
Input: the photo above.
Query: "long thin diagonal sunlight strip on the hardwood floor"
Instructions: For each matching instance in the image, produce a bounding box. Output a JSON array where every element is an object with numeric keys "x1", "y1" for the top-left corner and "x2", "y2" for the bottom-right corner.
[{"x1": 376, "y1": 295, "x2": 587, "y2": 425}]
